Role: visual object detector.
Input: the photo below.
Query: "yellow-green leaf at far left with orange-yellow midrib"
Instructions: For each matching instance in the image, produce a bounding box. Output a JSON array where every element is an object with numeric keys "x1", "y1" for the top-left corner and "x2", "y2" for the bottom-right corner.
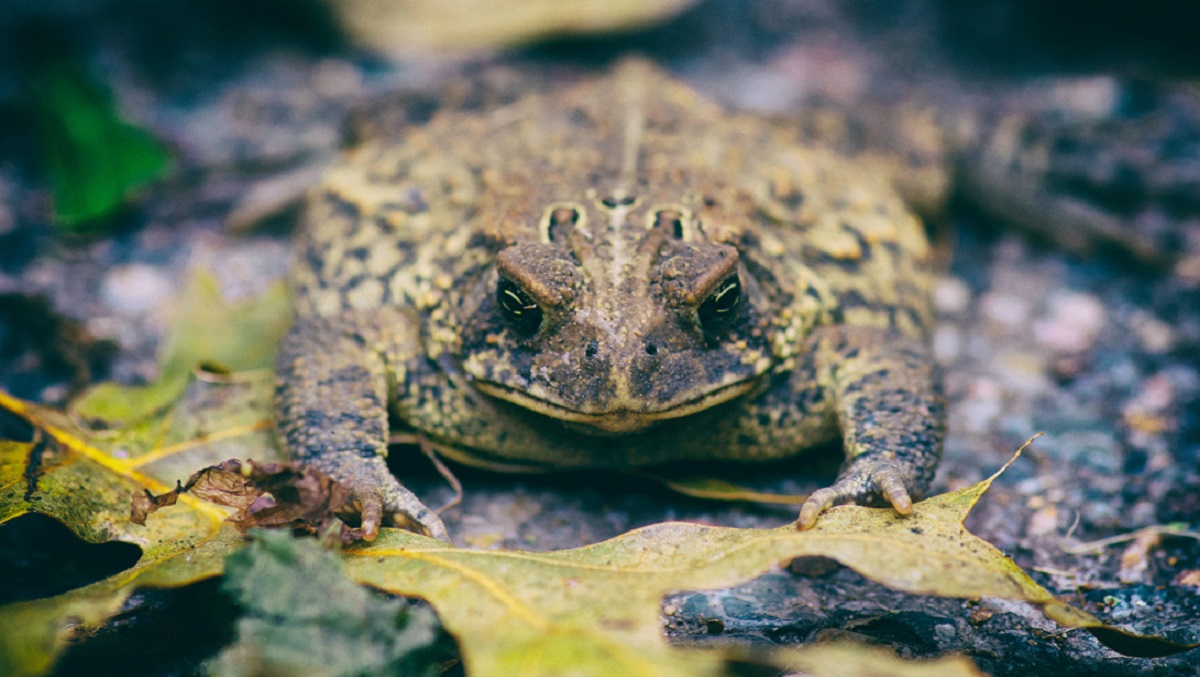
[{"x1": 0, "y1": 270, "x2": 288, "y2": 676}]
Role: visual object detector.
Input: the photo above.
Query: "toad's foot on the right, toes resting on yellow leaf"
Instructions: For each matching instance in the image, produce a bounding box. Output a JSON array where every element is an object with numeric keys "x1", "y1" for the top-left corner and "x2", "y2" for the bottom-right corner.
[{"x1": 796, "y1": 459, "x2": 912, "y2": 529}]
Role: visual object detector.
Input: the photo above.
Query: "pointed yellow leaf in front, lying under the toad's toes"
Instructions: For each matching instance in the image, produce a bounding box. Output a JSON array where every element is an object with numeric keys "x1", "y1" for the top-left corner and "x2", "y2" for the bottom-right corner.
[{"x1": 346, "y1": 446, "x2": 1192, "y2": 675}]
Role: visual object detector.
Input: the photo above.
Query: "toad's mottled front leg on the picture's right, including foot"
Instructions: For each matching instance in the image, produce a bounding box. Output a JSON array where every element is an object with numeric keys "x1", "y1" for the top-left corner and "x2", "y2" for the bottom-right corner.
[{"x1": 798, "y1": 326, "x2": 946, "y2": 529}]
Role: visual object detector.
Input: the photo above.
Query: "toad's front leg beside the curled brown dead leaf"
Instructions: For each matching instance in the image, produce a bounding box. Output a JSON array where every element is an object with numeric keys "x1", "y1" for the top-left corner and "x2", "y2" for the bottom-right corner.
[{"x1": 275, "y1": 317, "x2": 449, "y2": 540}]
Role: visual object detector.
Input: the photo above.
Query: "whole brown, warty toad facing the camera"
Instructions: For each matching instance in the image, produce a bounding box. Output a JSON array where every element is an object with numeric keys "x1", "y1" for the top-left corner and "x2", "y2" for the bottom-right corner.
[{"x1": 277, "y1": 62, "x2": 946, "y2": 538}]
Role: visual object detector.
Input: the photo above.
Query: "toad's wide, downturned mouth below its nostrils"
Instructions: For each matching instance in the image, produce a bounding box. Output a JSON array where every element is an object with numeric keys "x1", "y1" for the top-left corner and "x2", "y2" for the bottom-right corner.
[{"x1": 475, "y1": 379, "x2": 756, "y2": 433}]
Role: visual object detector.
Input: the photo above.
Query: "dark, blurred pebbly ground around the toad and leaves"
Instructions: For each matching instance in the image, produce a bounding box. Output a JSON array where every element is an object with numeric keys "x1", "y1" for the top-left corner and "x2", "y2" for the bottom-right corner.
[{"x1": 0, "y1": 0, "x2": 1200, "y2": 675}]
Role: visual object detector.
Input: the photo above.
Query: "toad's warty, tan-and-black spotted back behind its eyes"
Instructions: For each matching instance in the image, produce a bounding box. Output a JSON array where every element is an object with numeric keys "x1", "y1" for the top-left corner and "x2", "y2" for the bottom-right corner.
[{"x1": 296, "y1": 62, "x2": 930, "y2": 352}]
